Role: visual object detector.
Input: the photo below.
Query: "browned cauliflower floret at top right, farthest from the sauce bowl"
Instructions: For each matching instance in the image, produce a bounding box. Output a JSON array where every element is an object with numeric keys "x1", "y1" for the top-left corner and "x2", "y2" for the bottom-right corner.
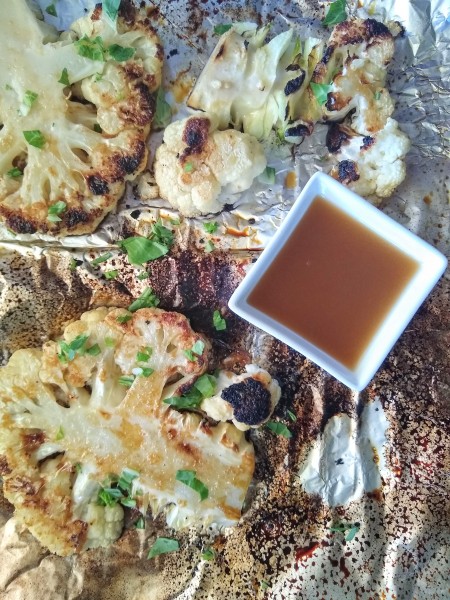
[{"x1": 311, "y1": 19, "x2": 394, "y2": 135}]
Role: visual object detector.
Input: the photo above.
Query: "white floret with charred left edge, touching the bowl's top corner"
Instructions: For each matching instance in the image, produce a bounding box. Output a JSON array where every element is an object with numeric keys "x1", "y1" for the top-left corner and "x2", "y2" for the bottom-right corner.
[{"x1": 327, "y1": 118, "x2": 411, "y2": 198}]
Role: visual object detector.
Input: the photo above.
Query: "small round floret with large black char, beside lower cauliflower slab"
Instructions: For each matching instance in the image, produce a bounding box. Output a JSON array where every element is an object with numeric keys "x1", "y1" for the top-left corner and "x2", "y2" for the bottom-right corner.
[{"x1": 200, "y1": 365, "x2": 281, "y2": 431}]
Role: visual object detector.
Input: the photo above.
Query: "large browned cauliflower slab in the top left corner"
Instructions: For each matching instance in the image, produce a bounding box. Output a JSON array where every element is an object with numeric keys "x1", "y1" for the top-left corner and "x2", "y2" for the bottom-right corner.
[{"x1": 0, "y1": 0, "x2": 162, "y2": 235}]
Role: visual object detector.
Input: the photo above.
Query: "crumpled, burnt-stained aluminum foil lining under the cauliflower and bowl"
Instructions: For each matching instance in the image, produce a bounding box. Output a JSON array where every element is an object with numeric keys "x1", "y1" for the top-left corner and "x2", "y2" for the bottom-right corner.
[{"x1": 0, "y1": 0, "x2": 450, "y2": 600}]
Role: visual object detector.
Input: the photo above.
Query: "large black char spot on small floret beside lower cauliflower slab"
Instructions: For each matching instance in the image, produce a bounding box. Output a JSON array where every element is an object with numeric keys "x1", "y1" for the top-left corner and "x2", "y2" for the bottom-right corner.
[{"x1": 221, "y1": 377, "x2": 271, "y2": 425}]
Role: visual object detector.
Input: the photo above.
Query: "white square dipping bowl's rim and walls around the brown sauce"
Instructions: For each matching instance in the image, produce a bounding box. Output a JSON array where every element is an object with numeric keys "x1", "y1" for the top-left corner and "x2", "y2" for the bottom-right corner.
[{"x1": 229, "y1": 173, "x2": 447, "y2": 390}]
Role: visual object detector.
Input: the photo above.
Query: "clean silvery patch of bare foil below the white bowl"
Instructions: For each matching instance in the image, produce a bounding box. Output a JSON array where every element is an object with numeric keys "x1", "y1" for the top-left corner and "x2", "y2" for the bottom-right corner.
[{"x1": 299, "y1": 399, "x2": 389, "y2": 506}]
